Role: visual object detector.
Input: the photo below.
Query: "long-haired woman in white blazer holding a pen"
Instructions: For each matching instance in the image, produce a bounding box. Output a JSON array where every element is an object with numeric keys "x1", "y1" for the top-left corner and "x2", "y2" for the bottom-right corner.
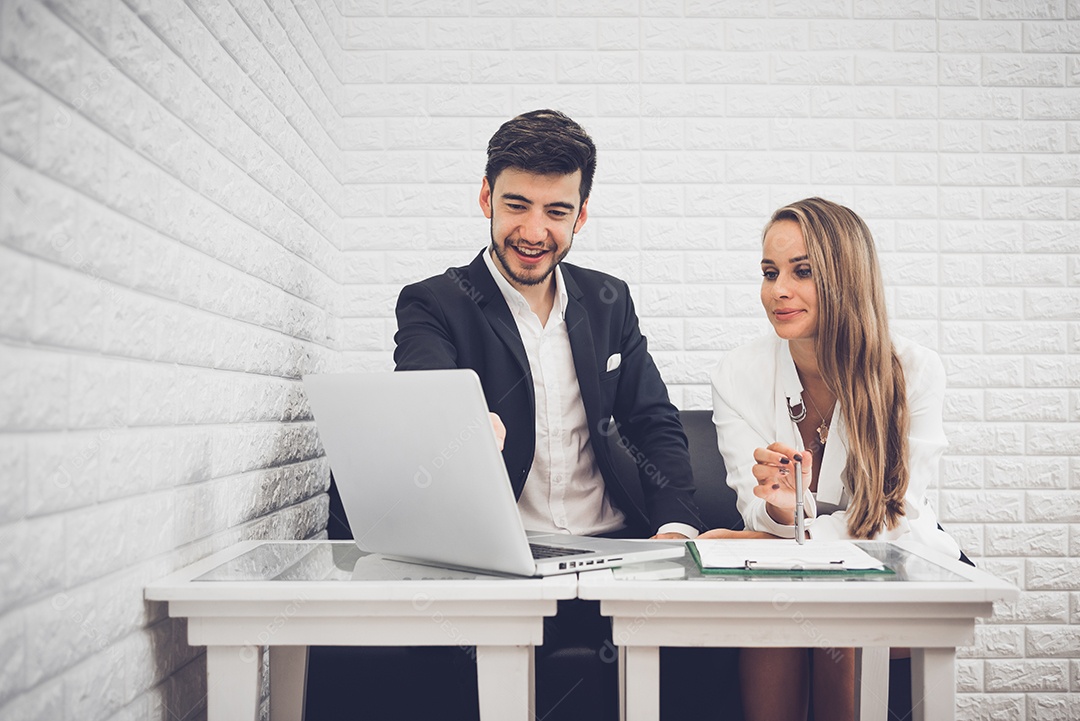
[{"x1": 702, "y1": 198, "x2": 960, "y2": 721}]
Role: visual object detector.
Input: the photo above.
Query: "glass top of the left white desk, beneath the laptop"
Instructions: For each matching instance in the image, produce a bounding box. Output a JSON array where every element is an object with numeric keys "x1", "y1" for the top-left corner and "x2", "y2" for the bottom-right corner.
[{"x1": 192, "y1": 541, "x2": 504, "y2": 582}]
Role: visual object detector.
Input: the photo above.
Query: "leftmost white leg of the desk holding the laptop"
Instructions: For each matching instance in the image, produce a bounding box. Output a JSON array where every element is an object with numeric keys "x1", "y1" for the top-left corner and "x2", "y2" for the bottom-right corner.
[{"x1": 206, "y1": 645, "x2": 262, "y2": 721}]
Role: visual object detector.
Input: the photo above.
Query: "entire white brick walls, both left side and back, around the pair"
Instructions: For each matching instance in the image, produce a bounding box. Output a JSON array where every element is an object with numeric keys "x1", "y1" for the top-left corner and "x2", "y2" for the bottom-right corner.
[{"x1": 0, "y1": 0, "x2": 1080, "y2": 721}]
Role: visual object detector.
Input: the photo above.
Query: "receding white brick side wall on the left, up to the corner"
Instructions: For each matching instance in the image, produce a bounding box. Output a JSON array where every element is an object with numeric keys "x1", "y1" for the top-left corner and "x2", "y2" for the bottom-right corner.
[{"x1": 0, "y1": 0, "x2": 339, "y2": 721}]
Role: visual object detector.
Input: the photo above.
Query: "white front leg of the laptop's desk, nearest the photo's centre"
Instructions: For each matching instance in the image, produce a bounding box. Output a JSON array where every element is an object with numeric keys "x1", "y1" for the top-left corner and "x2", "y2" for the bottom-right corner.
[{"x1": 476, "y1": 645, "x2": 536, "y2": 721}]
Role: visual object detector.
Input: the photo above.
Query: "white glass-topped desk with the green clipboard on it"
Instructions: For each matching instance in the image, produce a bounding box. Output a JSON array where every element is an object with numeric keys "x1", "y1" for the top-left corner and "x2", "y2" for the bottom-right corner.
[{"x1": 578, "y1": 541, "x2": 1020, "y2": 721}]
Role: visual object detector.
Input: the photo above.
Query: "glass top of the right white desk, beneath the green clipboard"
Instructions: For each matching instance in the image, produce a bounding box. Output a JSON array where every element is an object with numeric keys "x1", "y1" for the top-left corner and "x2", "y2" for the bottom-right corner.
[{"x1": 612, "y1": 541, "x2": 969, "y2": 583}]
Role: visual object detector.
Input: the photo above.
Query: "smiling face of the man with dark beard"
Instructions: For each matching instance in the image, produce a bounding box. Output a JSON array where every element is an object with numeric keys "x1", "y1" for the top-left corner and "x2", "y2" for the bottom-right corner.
[{"x1": 480, "y1": 167, "x2": 589, "y2": 291}]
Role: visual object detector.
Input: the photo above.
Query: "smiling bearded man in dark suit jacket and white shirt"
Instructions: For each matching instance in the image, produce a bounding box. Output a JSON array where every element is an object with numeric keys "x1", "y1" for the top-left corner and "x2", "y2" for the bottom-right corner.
[{"x1": 394, "y1": 110, "x2": 700, "y2": 719}]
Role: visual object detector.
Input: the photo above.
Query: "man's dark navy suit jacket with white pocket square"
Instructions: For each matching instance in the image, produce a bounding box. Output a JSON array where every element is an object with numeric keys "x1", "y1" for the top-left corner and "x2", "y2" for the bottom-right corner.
[{"x1": 394, "y1": 250, "x2": 701, "y2": 535}]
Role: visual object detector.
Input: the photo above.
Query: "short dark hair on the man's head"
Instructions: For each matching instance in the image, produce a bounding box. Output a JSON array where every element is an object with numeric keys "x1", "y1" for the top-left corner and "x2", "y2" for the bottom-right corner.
[{"x1": 484, "y1": 110, "x2": 596, "y2": 203}]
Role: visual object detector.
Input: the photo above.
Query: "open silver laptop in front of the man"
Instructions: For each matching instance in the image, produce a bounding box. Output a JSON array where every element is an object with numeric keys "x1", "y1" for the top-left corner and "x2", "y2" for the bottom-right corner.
[{"x1": 303, "y1": 369, "x2": 684, "y2": 575}]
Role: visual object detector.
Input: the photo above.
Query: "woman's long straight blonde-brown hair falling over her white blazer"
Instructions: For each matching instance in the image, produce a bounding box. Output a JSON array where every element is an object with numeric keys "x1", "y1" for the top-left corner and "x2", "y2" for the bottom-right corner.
[{"x1": 765, "y1": 198, "x2": 909, "y2": 539}]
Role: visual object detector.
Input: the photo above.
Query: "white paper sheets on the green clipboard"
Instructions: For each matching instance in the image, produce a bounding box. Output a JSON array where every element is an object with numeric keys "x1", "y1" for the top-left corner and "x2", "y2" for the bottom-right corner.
[{"x1": 687, "y1": 539, "x2": 892, "y2": 575}]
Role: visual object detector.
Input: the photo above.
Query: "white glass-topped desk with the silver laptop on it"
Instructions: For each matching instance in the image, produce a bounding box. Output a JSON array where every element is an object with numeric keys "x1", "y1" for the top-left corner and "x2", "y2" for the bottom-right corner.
[{"x1": 146, "y1": 541, "x2": 577, "y2": 721}]
